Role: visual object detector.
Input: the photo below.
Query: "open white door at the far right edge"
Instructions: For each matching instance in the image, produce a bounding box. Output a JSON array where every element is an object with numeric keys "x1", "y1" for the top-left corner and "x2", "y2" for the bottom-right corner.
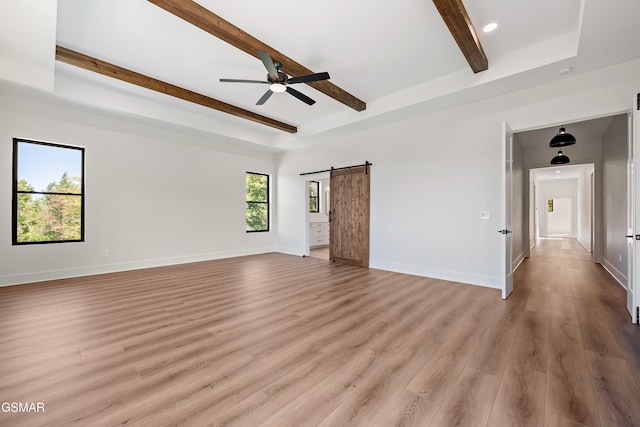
[{"x1": 627, "y1": 94, "x2": 640, "y2": 324}]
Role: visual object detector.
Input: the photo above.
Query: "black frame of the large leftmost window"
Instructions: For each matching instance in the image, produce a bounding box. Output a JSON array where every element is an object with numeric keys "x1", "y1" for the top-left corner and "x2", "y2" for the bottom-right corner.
[{"x1": 11, "y1": 138, "x2": 85, "y2": 246}]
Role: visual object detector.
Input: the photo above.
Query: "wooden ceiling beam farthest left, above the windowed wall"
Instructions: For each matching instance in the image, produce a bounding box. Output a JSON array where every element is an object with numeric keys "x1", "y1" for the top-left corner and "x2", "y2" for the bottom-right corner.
[{"x1": 56, "y1": 46, "x2": 298, "y2": 133}]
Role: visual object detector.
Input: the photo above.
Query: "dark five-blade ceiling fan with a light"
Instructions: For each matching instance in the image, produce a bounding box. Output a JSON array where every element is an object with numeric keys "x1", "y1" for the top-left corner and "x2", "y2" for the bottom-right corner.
[{"x1": 220, "y1": 51, "x2": 330, "y2": 105}]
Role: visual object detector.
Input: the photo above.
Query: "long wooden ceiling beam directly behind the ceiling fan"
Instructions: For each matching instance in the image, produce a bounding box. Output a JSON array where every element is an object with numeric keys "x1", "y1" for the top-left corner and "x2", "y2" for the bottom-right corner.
[{"x1": 148, "y1": 0, "x2": 367, "y2": 111}]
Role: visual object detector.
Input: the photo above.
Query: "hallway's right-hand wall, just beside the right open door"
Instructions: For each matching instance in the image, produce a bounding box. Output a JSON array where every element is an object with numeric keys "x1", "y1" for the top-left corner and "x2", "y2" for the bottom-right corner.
[{"x1": 602, "y1": 115, "x2": 628, "y2": 286}]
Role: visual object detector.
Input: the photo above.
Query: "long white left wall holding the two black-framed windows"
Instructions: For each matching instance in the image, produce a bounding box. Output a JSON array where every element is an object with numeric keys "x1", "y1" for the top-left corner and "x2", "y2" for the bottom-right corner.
[{"x1": 0, "y1": 94, "x2": 276, "y2": 285}]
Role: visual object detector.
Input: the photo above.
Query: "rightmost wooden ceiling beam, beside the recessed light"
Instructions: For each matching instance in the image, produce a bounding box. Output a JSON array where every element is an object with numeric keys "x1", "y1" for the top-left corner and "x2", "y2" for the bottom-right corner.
[{"x1": 433, "y1": 0, "x2": 489, "y2": 73}]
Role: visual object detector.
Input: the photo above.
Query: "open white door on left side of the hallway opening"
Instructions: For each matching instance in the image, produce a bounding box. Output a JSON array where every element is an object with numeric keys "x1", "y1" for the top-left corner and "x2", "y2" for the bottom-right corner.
[{"x1": 498, "y1": 122, "x2": 513, "y2": 299}]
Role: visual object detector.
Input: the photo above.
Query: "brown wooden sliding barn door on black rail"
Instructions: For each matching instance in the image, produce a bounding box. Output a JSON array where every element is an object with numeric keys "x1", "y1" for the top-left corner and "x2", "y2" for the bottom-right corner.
[{"x1": 329, "y1": 164, "x2": 371, "y2": 267}]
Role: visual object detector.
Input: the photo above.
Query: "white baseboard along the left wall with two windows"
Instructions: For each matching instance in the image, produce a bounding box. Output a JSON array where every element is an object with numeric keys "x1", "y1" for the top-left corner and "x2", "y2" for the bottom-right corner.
[{"x1": 0, "y1": 247, "x2": 275, "y2": 287}]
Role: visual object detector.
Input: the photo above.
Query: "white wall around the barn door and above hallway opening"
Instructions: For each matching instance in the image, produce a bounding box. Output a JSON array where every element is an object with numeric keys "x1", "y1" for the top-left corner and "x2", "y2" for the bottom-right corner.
[{"x1": 278, "y1": 61, "x2": 640, "y2": 287}]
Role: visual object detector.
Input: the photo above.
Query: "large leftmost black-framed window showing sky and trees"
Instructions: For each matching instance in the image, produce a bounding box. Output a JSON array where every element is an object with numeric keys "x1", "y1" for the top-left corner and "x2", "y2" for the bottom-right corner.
[{"x1": 12, "y1": 138, "x2": 84, "y2": 245}]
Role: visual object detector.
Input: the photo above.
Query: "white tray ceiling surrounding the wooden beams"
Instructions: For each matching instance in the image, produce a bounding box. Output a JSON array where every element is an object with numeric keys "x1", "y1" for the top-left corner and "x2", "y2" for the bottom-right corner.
[{"x1": 56, "y1": 0, "x2": 640, "y2": 149}]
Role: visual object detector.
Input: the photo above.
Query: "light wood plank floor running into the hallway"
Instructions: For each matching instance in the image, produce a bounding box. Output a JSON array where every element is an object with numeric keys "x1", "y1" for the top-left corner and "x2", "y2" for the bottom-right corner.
[{"x1": 0, "y1": 239, "x2": 640, "y2": 427}]
